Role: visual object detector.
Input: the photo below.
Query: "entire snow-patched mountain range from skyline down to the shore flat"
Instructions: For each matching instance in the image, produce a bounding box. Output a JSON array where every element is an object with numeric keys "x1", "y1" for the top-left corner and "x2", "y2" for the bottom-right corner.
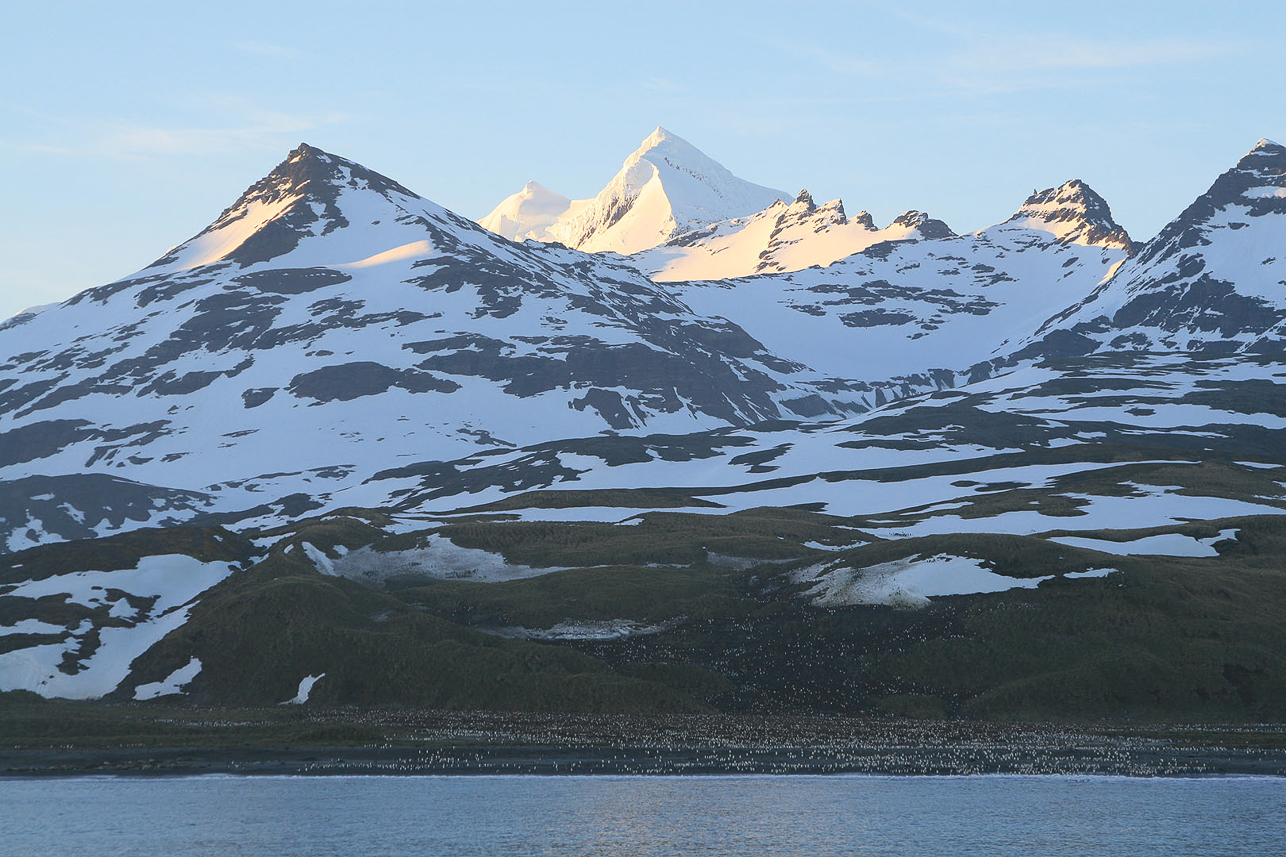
[{"x1": 0, "y1": 133, "x2": 1286, "y2": 717}]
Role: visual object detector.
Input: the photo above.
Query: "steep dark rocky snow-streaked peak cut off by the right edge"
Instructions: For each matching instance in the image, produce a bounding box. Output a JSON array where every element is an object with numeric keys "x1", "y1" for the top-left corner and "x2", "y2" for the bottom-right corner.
[{"x1": 1033, "y1": 140, "x2": 1286, "y2": 354}]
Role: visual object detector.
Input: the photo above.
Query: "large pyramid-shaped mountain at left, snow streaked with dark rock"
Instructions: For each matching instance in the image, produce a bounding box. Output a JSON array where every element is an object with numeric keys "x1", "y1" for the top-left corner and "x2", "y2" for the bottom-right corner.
[{"x1": 0, "y1": 145, "x2": 865, "y2": 549}]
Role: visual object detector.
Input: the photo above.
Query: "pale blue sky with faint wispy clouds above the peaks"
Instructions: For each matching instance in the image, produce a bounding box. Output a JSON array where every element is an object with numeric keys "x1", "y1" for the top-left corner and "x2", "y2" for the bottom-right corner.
[{"x1": 0, "y1": 0, "x2": 1286, "y2": 318}]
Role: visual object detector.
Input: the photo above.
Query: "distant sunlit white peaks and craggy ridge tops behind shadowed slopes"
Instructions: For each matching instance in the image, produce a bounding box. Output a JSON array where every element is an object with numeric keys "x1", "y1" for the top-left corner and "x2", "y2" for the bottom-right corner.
[{"x1": 478, "y1": 127, "x2": 1133, "y2": 282}]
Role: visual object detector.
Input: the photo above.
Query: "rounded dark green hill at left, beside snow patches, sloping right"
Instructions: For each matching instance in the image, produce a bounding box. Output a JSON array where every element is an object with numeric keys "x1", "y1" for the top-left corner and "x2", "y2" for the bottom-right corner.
[{"x1": 129, "y1": 551, "x2": 702, "y2": 710}]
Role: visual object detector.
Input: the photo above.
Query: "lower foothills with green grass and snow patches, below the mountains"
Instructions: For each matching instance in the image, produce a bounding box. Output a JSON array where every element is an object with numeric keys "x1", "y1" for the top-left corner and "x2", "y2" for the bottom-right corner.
[{"x1": 0, "y1": 344, "x2": 1286, "y2": 722}]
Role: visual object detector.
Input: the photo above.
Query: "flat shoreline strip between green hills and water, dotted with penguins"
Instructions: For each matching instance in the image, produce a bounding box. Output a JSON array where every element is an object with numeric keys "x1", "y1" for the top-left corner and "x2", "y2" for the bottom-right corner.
[{"x1": 0, "y1": 704, "x2": 1286, "y2": 779}]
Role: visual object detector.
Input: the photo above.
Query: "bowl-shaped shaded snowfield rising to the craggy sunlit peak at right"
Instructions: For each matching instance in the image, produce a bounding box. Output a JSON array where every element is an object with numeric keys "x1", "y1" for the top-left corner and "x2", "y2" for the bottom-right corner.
[{"x1": 669, "y1": 181, "x2": 1132, "y2": 380}]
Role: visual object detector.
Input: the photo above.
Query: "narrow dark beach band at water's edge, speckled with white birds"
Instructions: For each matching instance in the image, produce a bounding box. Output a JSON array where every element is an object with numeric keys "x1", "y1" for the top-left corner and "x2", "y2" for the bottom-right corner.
[{"x1": 10, "y1": 745, "x2": 1286, "y2": 780}]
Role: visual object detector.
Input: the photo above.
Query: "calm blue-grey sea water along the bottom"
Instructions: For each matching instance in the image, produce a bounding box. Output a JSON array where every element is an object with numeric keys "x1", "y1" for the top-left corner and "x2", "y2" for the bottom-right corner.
[{"x1": 0, "y1": 776, "x2": 1286, "y2": 857}]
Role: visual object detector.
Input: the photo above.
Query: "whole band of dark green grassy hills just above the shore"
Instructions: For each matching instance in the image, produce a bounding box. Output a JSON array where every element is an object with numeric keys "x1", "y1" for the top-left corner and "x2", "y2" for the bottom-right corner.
[{"x1": 0, "y1": 498, "x2": 1286, "y2": 720}]
